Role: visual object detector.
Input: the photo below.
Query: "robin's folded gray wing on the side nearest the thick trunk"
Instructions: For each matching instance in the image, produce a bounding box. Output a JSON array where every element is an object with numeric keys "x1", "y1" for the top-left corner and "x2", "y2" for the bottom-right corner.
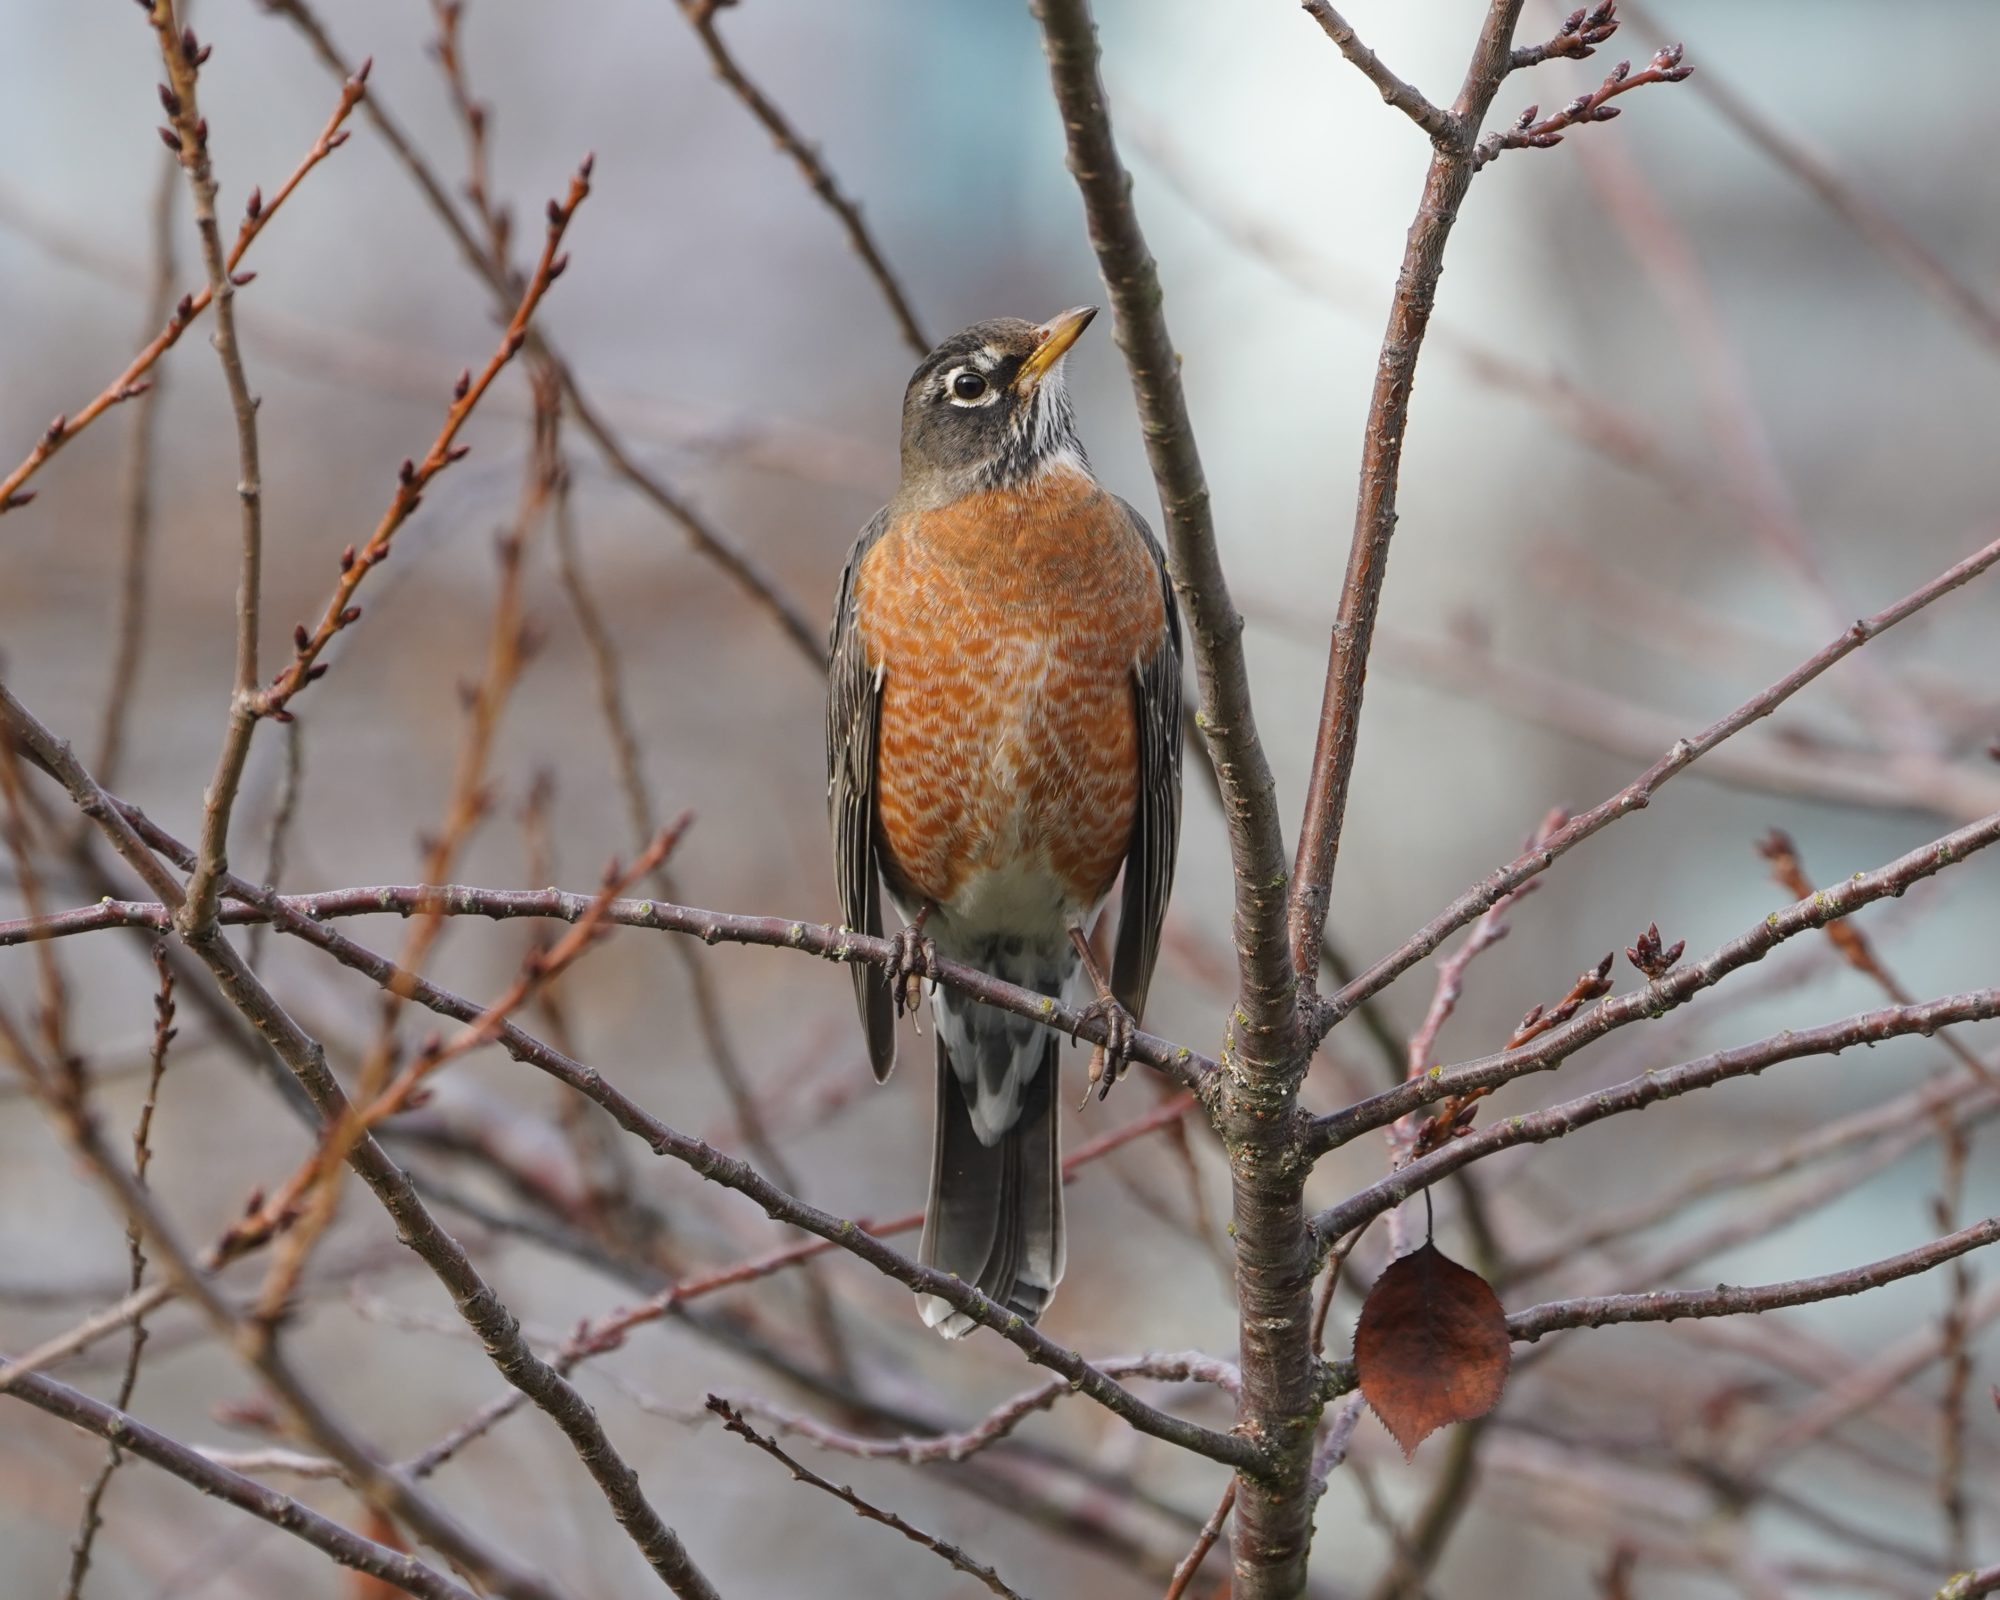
[{"x1": 1112, "y1": 500, "x2": 1180, "y2": 1018}]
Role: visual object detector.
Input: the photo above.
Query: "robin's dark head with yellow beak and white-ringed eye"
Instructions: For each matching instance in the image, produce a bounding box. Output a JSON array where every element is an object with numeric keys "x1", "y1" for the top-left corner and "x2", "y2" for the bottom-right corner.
[{"x1": 902, "y1": 306, "x2": 1098, "y2": 502}]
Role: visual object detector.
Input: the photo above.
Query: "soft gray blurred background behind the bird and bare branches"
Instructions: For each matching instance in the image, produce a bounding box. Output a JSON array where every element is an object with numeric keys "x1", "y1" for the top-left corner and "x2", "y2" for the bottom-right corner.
[{"x1": 0, "y1": 0, "x2": 2000, "y2": 1600}]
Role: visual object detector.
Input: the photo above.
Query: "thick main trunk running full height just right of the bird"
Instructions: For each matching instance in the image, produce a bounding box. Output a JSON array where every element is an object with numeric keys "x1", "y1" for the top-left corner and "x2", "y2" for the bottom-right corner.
[{"x1": 1034, "y1": 0, "x2": 1312, "y2": 1600}]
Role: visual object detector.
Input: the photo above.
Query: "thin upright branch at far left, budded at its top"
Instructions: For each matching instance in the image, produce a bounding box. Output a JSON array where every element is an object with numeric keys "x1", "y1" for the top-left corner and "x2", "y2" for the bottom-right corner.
[{"x1": 150, "y1": 0, "x2": 264, "y2": 940}]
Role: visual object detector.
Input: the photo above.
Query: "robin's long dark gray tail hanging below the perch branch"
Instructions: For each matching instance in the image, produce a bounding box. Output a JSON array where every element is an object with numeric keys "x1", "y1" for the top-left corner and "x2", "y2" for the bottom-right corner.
[{"x1": 918, "y1": 1030, "x2": 1066, "y2": 1338}]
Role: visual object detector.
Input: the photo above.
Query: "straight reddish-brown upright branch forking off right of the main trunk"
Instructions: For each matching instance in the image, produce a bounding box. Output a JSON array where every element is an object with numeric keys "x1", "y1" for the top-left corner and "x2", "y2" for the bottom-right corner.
[{"x1": 1290, "y1": 0, "x2": 1522, "y2": 990}]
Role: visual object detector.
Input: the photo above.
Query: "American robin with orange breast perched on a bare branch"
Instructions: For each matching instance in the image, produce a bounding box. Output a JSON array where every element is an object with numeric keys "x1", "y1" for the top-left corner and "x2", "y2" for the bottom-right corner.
[{"x1": 826, "y1": 308, "x2": 1180, "y2": 1338}]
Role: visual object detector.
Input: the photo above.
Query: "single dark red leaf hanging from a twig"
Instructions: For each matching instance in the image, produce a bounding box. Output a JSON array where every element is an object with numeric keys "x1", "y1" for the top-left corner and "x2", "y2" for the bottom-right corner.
[{"x1": 1354, "y1": 1242, "x2": 1514, "y2": 1456}]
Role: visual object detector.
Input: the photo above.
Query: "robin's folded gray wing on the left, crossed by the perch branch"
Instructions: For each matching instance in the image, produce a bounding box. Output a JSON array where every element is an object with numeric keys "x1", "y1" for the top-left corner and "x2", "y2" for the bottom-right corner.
[{"x1": 826, "y1": 510, "x2": 896, "y2": 1082}]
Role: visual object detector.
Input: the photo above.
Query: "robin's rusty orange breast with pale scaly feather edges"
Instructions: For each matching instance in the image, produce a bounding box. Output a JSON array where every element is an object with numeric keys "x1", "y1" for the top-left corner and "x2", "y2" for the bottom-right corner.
[{"x1": 854, "y1": 472, "x2": 1166, "y2": 908}]
